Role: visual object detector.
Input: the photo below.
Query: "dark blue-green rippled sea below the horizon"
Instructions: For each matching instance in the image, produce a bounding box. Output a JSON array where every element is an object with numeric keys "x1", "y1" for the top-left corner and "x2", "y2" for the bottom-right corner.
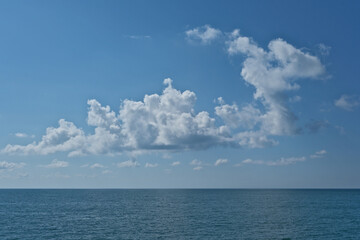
[{"x1": 0, "y1": 189, "x2": 360, "y2": 240}]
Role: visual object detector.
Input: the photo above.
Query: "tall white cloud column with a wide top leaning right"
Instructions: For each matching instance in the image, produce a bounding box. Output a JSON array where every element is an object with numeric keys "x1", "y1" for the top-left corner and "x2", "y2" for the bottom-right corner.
[{"x1": 227, "y1": 30, "x2": 325, "y2": 135}]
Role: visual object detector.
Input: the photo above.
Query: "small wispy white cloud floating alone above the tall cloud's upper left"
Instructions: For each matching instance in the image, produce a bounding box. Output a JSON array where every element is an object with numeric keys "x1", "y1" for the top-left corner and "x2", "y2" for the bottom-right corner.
[{"x1": 185, "y1": 25, "x2": 222, "y2": 44}]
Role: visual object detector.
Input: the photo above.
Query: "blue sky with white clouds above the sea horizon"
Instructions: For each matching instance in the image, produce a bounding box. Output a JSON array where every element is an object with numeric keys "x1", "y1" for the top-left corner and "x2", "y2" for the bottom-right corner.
[{"x1": 0, "y1": 0, "x2": 360, "y2": 188}]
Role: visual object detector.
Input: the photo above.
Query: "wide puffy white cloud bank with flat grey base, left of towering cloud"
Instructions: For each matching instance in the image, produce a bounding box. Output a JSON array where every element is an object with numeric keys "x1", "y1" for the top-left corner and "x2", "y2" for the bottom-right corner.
[{"x1": 3, "y1": 79, "x2": 239, "y2": 156}]
